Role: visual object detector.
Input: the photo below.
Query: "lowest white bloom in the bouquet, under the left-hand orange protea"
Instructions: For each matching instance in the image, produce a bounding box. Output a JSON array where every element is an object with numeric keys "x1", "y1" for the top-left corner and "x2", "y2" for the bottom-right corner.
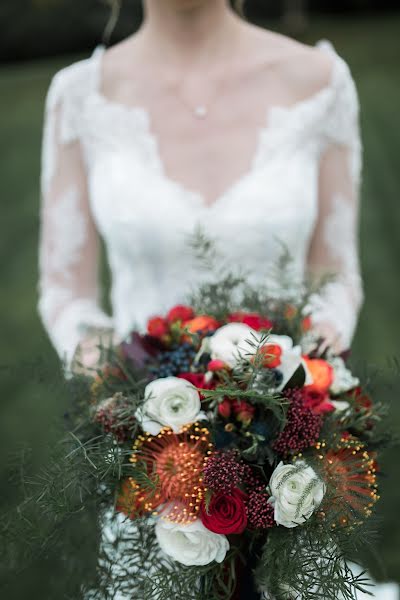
[{"x1": 156, "y1": 518, "x2": 229, "y2": 567}]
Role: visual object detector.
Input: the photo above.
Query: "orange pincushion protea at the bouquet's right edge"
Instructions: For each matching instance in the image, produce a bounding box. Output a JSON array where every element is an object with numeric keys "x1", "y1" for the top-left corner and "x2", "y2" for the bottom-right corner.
[{"x1": 316, "y1": 437, "x2": 379, "y2": 527}]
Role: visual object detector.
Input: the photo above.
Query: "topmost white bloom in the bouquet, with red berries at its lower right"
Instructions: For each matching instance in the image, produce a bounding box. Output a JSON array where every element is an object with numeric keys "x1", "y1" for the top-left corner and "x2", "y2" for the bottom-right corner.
[{"x1": 208, "y1": 323, "x2": 260, "y2": 368}]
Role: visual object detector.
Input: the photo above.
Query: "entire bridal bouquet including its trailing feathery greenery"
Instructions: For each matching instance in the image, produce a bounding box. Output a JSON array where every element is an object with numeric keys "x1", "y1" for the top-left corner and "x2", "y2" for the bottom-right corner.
[{"x1": 0, "y1": 239, "x2": 390, "y2": 600}]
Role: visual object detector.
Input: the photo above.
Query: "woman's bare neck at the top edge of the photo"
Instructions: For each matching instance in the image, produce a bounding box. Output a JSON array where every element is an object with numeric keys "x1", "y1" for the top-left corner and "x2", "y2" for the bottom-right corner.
[{"x1": 136, "y1": 0, "x2": 243, "y2": 67}]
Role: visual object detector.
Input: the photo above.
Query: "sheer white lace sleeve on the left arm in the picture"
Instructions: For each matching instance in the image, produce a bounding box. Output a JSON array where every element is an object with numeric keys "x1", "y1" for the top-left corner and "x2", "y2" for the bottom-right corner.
[{"x1": 38, "y1": 68, "x2": 112, "y2": 373}]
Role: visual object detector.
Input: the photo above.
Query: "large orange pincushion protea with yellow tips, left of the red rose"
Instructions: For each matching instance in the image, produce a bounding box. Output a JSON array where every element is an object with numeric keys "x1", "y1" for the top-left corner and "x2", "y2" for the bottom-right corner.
[{"x1": 124, "y1": 423, "x2": 213, "y2": 523}]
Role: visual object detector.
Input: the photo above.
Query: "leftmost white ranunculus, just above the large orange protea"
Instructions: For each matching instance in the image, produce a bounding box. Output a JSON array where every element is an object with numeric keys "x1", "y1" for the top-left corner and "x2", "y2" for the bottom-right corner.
[{"x1": 135, "y1": 377, "x2": 205, "y2": 435}]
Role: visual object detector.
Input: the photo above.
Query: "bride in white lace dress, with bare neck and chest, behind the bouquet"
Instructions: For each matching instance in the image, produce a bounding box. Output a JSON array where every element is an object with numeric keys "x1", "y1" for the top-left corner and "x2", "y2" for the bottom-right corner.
[{"x1": 38, "y1": 0, "x2": 397, "y2": 600}]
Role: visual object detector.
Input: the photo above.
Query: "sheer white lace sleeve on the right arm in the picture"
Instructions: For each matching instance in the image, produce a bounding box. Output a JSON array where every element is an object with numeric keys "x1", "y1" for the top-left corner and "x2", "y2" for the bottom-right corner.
[{"x1": 309, "y1": 55, "x2": 363, "y2": 352}]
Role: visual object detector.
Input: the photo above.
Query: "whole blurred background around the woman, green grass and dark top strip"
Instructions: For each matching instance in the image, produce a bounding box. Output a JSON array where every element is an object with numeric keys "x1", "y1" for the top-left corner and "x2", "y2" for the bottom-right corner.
[{"x1": 0, "y1": 0, "x2": 400, "y2": 600}]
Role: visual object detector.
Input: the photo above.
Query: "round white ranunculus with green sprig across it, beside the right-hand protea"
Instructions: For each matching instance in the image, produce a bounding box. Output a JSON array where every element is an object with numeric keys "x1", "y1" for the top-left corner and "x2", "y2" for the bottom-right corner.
[{"x1": 269, "y1": 460, "x2": 326, "y2": 527}]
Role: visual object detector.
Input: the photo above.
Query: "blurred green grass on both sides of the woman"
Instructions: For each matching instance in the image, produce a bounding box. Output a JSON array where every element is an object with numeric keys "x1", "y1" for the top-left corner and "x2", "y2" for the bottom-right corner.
[{"x1": 0, "y1": 16, "x2": 400, "y2": 600}]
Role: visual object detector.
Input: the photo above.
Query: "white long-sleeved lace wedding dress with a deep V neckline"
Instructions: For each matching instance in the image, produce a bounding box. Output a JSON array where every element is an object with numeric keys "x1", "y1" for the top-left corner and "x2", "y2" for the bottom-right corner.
[{"x1": 38, "y1": 42, "x2": 397, "y2": 600}]
